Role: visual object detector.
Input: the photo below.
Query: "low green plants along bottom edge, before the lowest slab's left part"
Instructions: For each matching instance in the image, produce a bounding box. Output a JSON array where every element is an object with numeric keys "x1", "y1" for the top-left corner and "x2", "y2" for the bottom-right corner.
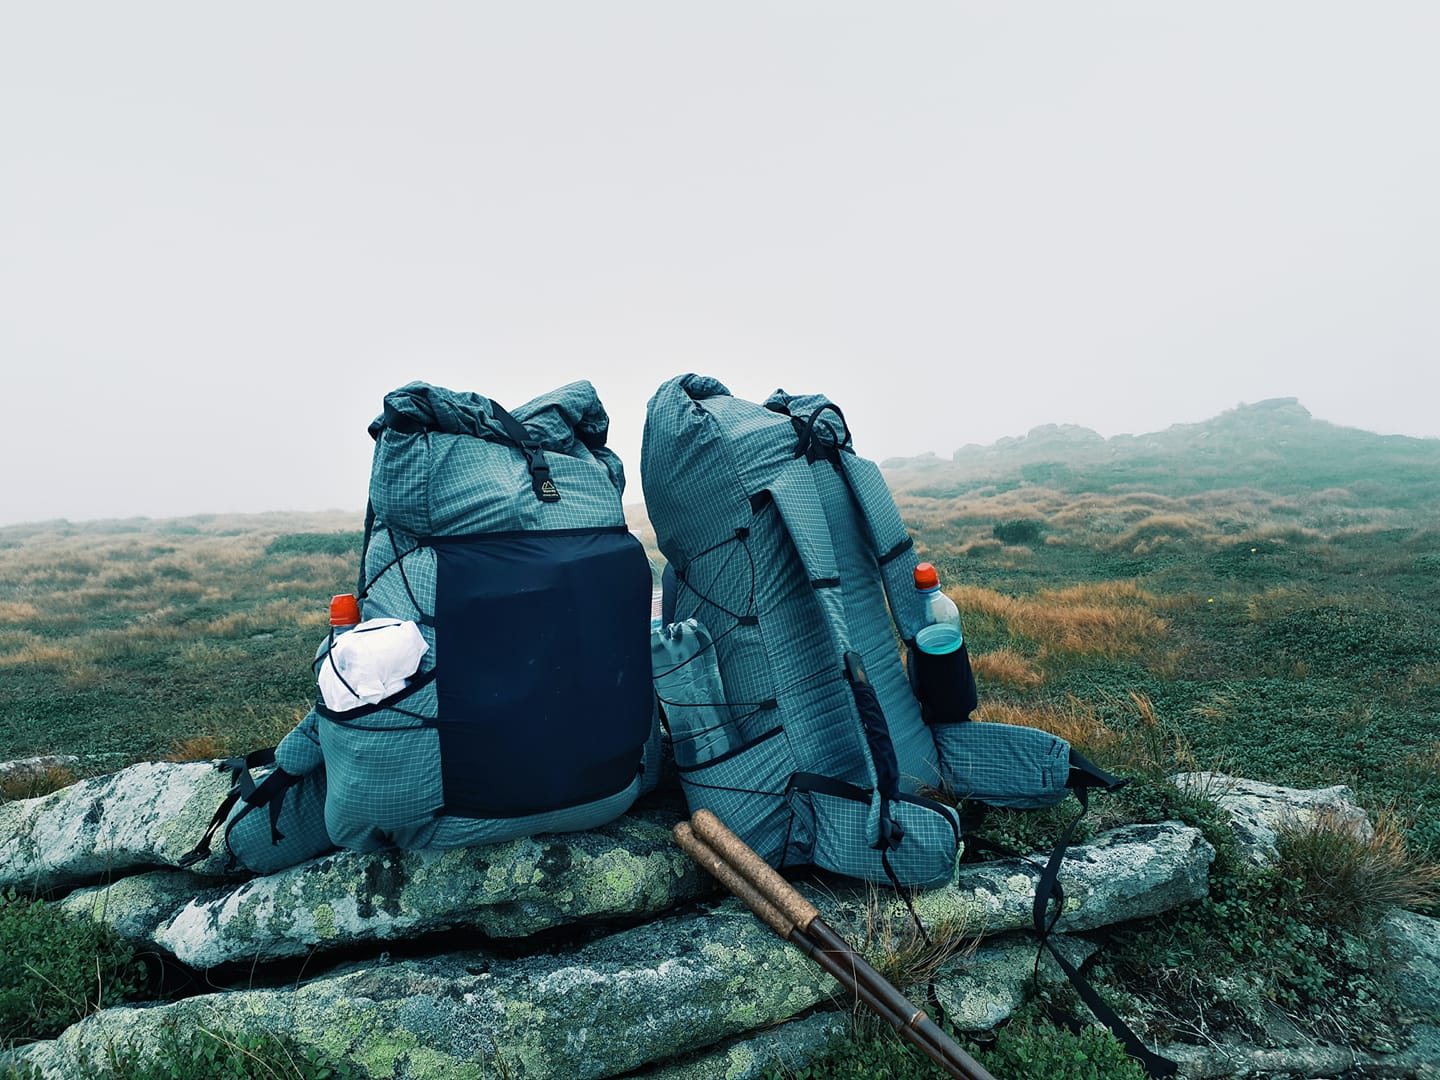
[{"x1": 81, "y1": 1025, "x2": 366, "y2": 1080}]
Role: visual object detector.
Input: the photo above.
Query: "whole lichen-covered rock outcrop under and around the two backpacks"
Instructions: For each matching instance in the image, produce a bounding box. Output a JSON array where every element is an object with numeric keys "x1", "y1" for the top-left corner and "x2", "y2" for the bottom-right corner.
[{"x1": 0, "y1": 765, "x2": 1440, "y2": 1080}]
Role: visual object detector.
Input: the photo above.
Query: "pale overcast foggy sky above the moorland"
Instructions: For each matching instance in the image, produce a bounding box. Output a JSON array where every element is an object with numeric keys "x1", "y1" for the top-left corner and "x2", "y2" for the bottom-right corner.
[{"x1": 0, "y1": 0, "x2": 1440, "y2": 524}]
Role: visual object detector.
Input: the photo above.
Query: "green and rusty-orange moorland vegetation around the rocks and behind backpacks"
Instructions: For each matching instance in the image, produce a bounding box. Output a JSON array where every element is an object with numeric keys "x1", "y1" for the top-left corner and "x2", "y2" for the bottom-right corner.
[{"x1": 0, "y1": 403, "x2": 1440, "y2": 1080}]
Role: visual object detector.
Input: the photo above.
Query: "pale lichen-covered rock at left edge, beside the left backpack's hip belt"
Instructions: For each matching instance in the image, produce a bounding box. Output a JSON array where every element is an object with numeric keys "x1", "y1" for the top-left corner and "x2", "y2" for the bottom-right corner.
[{"x1": 0, "y1": 762, "x2": 230, "y2": 888}]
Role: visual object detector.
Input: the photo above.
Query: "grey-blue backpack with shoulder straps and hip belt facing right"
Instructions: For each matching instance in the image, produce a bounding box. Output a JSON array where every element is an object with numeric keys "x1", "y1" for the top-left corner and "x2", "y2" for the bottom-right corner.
[{"x1": 641, "y1": 374, "x2": 1116, "y2": 886}]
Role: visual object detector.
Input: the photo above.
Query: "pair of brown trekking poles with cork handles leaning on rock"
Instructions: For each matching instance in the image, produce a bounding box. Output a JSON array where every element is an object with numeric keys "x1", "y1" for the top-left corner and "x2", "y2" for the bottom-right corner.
[{"x1": 675, "y1": 809, "x2": 995, "y2": 1080}]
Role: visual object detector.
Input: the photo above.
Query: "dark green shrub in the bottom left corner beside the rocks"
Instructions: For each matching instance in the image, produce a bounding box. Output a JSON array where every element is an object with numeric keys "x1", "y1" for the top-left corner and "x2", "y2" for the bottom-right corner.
[{"x1": 0, "y1": 888, "x2": 148, "y2": 1043}]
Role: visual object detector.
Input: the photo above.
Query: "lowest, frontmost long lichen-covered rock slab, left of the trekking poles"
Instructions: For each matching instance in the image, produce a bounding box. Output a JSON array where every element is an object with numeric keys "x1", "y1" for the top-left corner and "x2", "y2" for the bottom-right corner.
[{"x1": 22, "y1": 900, "x2": 835, "y2": 1080}]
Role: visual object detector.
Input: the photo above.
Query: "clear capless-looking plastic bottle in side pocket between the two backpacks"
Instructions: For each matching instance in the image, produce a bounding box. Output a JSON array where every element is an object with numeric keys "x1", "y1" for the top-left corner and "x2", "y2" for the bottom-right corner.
[{"x1": 649, "y1": 619, "x2": 740, "y2": 768}]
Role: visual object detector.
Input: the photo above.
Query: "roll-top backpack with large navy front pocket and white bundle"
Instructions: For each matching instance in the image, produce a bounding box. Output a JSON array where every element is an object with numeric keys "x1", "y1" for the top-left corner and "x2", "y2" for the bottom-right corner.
[{"x1": 194, "y1": 382, "x2": 660, "y2": 873}]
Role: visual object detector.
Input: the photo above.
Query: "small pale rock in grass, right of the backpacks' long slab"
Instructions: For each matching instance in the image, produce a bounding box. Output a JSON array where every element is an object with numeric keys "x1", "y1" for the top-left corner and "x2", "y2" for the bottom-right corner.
[{"x1": 1171, "y1": 772, "x2": 1371, "y2": 865}]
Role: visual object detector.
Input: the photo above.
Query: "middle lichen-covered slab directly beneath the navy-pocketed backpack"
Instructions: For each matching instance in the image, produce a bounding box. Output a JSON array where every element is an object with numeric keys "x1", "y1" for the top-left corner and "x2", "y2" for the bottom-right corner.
[{"x1": 141, "y1": 809, "x2": 714, "y2": 968}]
